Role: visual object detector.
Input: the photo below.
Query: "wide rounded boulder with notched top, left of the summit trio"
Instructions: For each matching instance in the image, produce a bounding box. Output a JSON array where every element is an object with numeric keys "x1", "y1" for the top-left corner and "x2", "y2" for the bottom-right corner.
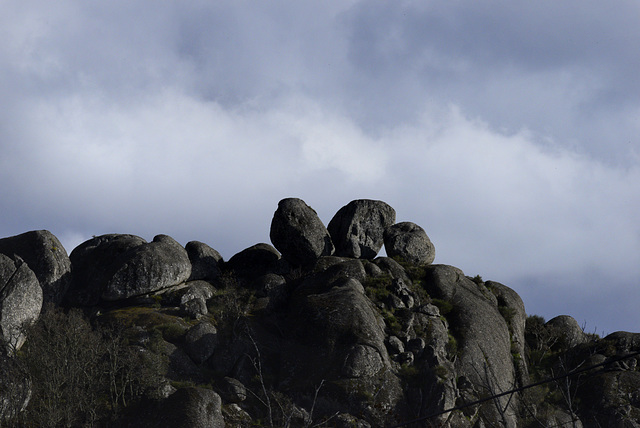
[{"x1": 68, "y1": 234, "x2": 191, "y2": 305}]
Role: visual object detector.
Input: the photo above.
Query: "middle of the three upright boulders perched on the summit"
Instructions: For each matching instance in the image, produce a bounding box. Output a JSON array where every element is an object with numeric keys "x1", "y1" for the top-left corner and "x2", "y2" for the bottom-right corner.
[{"x1": 327, "y1": 199, "x2": 396, "y2": 259}]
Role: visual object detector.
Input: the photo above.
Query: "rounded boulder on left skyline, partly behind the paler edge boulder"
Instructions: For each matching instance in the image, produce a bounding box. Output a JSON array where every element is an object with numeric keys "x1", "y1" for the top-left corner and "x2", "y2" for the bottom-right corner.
[{"x1": 0, "y1": 230, "x2": 71, "y2": 304}]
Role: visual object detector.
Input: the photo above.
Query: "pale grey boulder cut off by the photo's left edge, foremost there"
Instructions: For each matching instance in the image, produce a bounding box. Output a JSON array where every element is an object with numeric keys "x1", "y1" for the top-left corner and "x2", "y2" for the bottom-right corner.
[{"x1": 0, "y1": 254, "x2": 42, "y2": 354}]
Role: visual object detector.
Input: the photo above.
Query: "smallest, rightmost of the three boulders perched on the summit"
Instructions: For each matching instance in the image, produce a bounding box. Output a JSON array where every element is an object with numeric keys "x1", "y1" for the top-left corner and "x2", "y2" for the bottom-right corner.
[{"x1": 384, "y1": 221, "x2": 436, "y2": 265}]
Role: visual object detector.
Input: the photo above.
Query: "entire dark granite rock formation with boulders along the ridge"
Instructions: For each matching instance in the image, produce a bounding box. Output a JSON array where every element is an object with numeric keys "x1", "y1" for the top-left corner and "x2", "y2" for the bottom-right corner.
[{"x1": 0, "y1": 198, "x2": 640, "y2": 428}]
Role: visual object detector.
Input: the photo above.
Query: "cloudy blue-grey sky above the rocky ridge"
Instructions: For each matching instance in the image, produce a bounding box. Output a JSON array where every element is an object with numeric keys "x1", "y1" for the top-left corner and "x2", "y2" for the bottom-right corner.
[{"x1": 0, "y1": 0, "x2": 640, "y2": 334}]
